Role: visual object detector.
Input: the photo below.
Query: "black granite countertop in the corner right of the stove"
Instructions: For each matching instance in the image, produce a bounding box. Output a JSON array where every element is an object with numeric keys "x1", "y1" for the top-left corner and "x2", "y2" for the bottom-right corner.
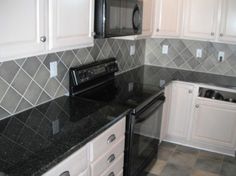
[{"x1": 118, "y1": 65, "x2": 236, "y2": 89}]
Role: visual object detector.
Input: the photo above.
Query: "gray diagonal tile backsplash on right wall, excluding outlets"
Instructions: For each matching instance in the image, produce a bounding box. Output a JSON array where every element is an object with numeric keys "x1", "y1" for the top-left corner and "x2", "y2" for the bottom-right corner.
[{"x1": 145, "y1": 39, "x2": 236, "y2": 77}]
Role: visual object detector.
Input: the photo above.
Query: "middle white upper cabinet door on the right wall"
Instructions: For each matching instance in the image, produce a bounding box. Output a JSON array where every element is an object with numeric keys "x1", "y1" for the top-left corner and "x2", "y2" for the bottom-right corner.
[{"x1": 184, "y1": 0, "x2": 219, "y2": 39}]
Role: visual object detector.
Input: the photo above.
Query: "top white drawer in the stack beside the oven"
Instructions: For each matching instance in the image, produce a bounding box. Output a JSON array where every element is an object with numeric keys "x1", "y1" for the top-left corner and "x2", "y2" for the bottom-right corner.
[{"x1": 90, "y1": 118, "x2": 125, "y2": 161}]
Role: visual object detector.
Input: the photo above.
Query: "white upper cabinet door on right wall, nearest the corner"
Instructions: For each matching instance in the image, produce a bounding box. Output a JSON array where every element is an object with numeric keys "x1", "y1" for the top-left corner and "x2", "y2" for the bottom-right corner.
[{"x1": 154, "y1": 0, "x2": 183, "y2": 36}]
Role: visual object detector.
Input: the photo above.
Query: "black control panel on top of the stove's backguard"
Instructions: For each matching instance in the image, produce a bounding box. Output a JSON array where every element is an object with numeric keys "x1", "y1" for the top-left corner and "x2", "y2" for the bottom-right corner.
[{"x1": 70, "y1": 60, "x2": 119, "y2": 86}]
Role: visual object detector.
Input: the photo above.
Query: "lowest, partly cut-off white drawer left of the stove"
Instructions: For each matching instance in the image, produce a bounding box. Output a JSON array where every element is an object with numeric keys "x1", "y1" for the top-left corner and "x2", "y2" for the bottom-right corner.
[{"x1": 101, "y1": 154, "x2": 124, "y2": 176}]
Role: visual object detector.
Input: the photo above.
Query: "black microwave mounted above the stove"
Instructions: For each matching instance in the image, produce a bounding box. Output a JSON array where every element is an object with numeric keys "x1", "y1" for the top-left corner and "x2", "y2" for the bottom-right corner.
[{"x1": 94, "y1": 0, "x2": 143, "y2": 38}]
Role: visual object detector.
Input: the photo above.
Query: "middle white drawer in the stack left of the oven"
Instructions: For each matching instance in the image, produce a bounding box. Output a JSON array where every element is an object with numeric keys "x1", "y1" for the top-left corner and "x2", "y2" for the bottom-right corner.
[{"x1": 91, "y1": 137, "x2": 125, "y2": 176}]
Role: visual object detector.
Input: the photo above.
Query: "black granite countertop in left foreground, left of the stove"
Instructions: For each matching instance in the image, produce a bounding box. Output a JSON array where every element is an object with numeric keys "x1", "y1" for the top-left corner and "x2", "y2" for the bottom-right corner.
[{"x1": 0, "y1": 96, "x2": 128, "y2": 176}]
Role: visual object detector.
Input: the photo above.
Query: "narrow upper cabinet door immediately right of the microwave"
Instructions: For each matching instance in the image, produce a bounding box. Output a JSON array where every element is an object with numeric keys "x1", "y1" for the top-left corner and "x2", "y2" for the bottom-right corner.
[{"x1": 142, "y1": 0, "x2": 154, "y2": 36}]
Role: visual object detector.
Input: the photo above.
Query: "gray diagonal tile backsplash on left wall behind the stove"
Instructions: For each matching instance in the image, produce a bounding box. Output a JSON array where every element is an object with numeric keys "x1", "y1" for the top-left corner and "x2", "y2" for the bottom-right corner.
[{"x1": 0, "y1": 39, "x2": 145, "y2": 119}]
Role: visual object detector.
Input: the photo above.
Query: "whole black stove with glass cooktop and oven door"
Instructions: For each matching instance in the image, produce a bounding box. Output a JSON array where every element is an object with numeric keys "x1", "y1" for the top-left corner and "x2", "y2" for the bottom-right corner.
[{"x1": 70, "y1": 58, "x2": 165, "y2": 176}]
